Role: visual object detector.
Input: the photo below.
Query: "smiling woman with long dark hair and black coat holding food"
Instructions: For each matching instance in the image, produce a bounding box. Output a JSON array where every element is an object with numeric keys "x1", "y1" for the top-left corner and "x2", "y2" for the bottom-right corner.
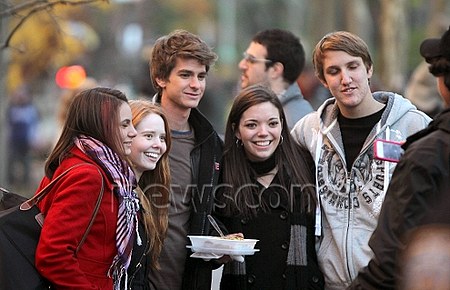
[{"x1": 216, "y1": 85, "x2": 324, "y2": 290}]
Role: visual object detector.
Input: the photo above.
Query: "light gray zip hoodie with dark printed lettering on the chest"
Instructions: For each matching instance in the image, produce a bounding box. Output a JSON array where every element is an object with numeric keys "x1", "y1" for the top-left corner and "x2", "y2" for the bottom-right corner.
[{"x1": 291, "y1": 92, "x2": 431, "y2": 289}]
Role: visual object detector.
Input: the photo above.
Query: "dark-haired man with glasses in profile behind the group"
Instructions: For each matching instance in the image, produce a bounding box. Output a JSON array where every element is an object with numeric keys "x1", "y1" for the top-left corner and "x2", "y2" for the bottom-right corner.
[{"x1": 239, "y1": 29, "x2": 313, "y2": 129}]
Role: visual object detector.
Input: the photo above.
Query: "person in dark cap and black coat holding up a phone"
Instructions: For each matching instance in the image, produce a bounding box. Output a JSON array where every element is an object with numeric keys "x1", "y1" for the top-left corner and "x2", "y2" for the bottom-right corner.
[{"x1": 348, "y1": 27, "x2": 450, "y2": 289}]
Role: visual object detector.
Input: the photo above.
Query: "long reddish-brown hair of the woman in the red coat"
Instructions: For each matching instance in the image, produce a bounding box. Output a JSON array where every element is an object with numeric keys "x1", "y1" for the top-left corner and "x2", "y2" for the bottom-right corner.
[{"x1": 45, "y1": 87, "x2": 128, "y2": 178}]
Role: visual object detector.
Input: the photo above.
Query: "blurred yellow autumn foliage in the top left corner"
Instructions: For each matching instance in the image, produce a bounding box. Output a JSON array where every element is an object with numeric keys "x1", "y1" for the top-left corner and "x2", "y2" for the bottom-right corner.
[{"x1": 0, "y1": 0, "x2": 106, "y2": 92}]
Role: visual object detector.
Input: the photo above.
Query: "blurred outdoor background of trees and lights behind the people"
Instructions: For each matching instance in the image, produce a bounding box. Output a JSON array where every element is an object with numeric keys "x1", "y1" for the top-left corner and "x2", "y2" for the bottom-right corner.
[{"x1": 0, "y1": 0, "x2": 450, "y2": 195}]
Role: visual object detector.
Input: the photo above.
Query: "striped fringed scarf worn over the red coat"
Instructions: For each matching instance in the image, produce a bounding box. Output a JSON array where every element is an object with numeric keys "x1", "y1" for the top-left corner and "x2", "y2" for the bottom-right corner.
[{"x1": 75, "y1": 135, "x2": 140, "y2": 289}]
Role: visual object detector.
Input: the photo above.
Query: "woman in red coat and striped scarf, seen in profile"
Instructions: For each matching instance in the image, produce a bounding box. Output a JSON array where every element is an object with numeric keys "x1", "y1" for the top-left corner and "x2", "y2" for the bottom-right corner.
[{"x1": 35, "y1": 88, "x2": 139, "y2": 289}]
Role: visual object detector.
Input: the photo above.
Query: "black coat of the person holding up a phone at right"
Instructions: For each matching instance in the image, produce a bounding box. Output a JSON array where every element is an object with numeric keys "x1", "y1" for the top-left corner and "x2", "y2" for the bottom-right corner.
[{"x1": 348, "y1": 109, "x2": 450, "y2": 290}]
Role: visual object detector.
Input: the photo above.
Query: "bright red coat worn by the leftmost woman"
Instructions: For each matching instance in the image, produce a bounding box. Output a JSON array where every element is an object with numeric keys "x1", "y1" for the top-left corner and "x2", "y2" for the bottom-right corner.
[{"x1": 35, "y1": 147, "x2": 118, "y2": 289}]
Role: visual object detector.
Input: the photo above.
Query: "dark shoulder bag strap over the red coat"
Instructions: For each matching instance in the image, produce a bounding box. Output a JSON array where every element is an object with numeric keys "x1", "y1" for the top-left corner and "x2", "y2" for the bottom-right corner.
[{"x1": 20, "y1": 163, "x2": 105, "y2": 256}]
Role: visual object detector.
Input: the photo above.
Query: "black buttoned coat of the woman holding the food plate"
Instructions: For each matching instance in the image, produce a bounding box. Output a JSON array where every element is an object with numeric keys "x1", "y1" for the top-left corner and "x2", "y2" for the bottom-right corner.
[{"x1": 218, "y1": 174, "x2": 324, "y2": 290}]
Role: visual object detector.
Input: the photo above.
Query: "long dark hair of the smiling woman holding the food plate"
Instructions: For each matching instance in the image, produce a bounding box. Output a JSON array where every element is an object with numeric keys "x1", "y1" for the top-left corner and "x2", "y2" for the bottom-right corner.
[{"x1": 218, "y1": 85, "x2": 316, "y2": 217}]
